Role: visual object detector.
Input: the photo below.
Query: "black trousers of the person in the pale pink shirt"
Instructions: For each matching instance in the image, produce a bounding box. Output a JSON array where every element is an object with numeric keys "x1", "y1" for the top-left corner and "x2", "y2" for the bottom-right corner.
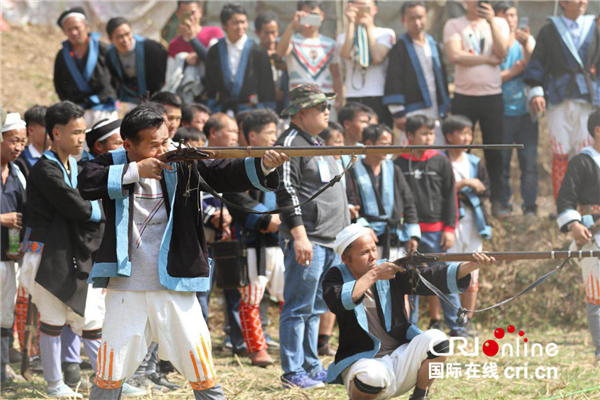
[{"x1": 452, "y1": 93, "x2": 504, "y2": 202}]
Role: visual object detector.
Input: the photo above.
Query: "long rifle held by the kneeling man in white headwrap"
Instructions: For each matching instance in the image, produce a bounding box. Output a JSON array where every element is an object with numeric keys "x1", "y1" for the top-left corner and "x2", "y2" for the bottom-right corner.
[{"x1": 394, "y1": 250, "x2": 600, "y2": 265}]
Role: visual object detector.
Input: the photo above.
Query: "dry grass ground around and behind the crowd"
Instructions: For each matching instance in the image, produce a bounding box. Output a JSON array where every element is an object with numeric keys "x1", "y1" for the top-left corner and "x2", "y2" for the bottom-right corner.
[{"x1": 0, "y1": 27, "x2": 600, "y2": 400}]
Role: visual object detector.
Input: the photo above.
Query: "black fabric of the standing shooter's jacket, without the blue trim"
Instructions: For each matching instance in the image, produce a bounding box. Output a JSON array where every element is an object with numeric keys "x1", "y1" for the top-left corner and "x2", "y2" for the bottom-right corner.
[{"x1": 79, "y1": 153, "x2": 279, "y2": 291}]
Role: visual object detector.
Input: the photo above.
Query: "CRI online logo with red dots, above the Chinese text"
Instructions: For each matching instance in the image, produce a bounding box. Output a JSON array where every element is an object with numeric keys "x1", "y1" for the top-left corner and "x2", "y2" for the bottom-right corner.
[{"x1": 429, "y1": 325, "x2": 558, "y2": 357}]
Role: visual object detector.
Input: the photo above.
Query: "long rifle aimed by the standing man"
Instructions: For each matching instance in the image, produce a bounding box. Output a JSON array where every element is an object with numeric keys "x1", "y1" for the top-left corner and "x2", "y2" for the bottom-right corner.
[{"x1": 160, "y1": 144, "x2": 523, "y2": 162}]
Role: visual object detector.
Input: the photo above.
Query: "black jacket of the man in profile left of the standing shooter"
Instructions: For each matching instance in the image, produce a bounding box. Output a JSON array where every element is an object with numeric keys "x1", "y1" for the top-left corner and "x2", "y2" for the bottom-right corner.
[{"x1": 24, "y1": 156, "x2": 101, "y2": 316}]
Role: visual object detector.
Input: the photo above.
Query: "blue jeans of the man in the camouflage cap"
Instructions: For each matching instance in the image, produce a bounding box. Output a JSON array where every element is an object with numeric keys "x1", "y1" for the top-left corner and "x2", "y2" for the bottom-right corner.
[{"x1": 279, "y1": 240, "x2": 342, "y2": 378}]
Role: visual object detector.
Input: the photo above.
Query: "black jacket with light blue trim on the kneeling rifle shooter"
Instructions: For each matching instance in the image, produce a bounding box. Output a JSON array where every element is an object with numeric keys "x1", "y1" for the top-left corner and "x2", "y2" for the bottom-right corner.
[{"x1": 323, "y1": 263, "x2": 471, "y2": 384}]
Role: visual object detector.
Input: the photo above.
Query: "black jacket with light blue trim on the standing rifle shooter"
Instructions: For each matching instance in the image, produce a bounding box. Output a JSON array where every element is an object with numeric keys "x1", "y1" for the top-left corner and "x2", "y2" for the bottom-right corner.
[{"x1": 79, "y1": 149, "x2": 279, "y2": 292}]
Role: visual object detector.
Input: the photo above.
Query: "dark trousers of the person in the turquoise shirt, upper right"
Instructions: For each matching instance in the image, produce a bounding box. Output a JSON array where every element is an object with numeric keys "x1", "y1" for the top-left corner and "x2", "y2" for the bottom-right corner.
[{"x1": 500, "y1": 114, "x2": 539, "y2": 208}]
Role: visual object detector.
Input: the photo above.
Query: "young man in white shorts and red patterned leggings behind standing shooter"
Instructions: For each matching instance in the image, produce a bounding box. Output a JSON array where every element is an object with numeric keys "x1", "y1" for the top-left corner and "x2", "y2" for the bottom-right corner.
[{"x1": 226, "y1": 110, "x2": 284, "y2": 367}]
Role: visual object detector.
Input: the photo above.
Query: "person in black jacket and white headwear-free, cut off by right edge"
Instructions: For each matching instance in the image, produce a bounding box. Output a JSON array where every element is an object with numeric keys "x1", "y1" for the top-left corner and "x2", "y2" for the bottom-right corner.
[{"x1": 556, "y1": 110, "x2": 600, "y2": 362}]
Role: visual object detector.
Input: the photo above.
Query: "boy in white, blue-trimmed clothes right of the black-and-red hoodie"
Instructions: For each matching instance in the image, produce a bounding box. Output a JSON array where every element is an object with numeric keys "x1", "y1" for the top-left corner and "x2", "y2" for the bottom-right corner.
[{"x1": 438, "y1": 115, "x2": 492, "y2": 328}]
